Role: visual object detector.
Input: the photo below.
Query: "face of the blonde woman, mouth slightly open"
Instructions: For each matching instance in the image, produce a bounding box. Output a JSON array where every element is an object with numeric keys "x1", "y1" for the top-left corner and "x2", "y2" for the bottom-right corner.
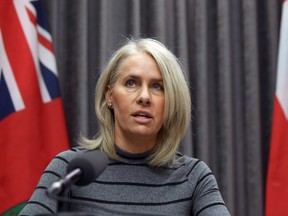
[{"x1": 106, "y1": 54, "x2": 165, "y2": 148}]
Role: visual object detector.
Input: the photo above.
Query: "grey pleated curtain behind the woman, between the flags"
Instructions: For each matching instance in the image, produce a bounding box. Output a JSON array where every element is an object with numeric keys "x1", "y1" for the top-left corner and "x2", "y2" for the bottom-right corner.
[{"x1": 45, "y1": 0, "x2": 282, "y2": 216}]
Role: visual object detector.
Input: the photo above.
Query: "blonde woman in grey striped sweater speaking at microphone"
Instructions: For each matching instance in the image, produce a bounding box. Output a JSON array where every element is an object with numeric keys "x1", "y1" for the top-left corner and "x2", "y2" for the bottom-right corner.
[{"x1": 21, "y1": 39, "x2": 230, "y2": 216}]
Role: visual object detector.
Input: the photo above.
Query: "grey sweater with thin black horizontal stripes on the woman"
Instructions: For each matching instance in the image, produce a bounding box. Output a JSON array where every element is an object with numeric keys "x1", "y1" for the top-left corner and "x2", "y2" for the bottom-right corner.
[{"x1": 20, "y1": 148, "x2": 230, "y2": 216}]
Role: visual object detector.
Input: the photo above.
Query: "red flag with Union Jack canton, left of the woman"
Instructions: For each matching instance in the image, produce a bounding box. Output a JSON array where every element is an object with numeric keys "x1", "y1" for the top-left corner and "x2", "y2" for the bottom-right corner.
[{"x1": 0, "y1": 0, "x2": 69, "y2": 215}]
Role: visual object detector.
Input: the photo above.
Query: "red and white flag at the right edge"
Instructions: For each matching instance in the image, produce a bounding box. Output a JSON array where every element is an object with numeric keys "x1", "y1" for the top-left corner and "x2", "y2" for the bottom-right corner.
[{"x1": 266, "y1": 0, "x2": 288, "y2": 216}]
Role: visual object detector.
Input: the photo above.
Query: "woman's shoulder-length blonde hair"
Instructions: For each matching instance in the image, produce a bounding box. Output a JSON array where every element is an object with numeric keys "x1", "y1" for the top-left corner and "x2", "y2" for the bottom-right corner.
[{"x1": 81, "y1": 38, "x2": 191, "y2": 166}]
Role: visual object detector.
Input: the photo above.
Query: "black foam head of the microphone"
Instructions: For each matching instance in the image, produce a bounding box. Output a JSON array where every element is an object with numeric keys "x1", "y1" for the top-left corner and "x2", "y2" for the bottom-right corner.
[{"x1": 67, "y1": 150, "x2": 108, "y2": 186}]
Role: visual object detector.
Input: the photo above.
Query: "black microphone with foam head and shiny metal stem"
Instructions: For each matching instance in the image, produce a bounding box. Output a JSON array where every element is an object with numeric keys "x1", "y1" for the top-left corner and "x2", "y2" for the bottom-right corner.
[{"x1": 47, "y1": 151, "x2": 108, "y2": 195}]
